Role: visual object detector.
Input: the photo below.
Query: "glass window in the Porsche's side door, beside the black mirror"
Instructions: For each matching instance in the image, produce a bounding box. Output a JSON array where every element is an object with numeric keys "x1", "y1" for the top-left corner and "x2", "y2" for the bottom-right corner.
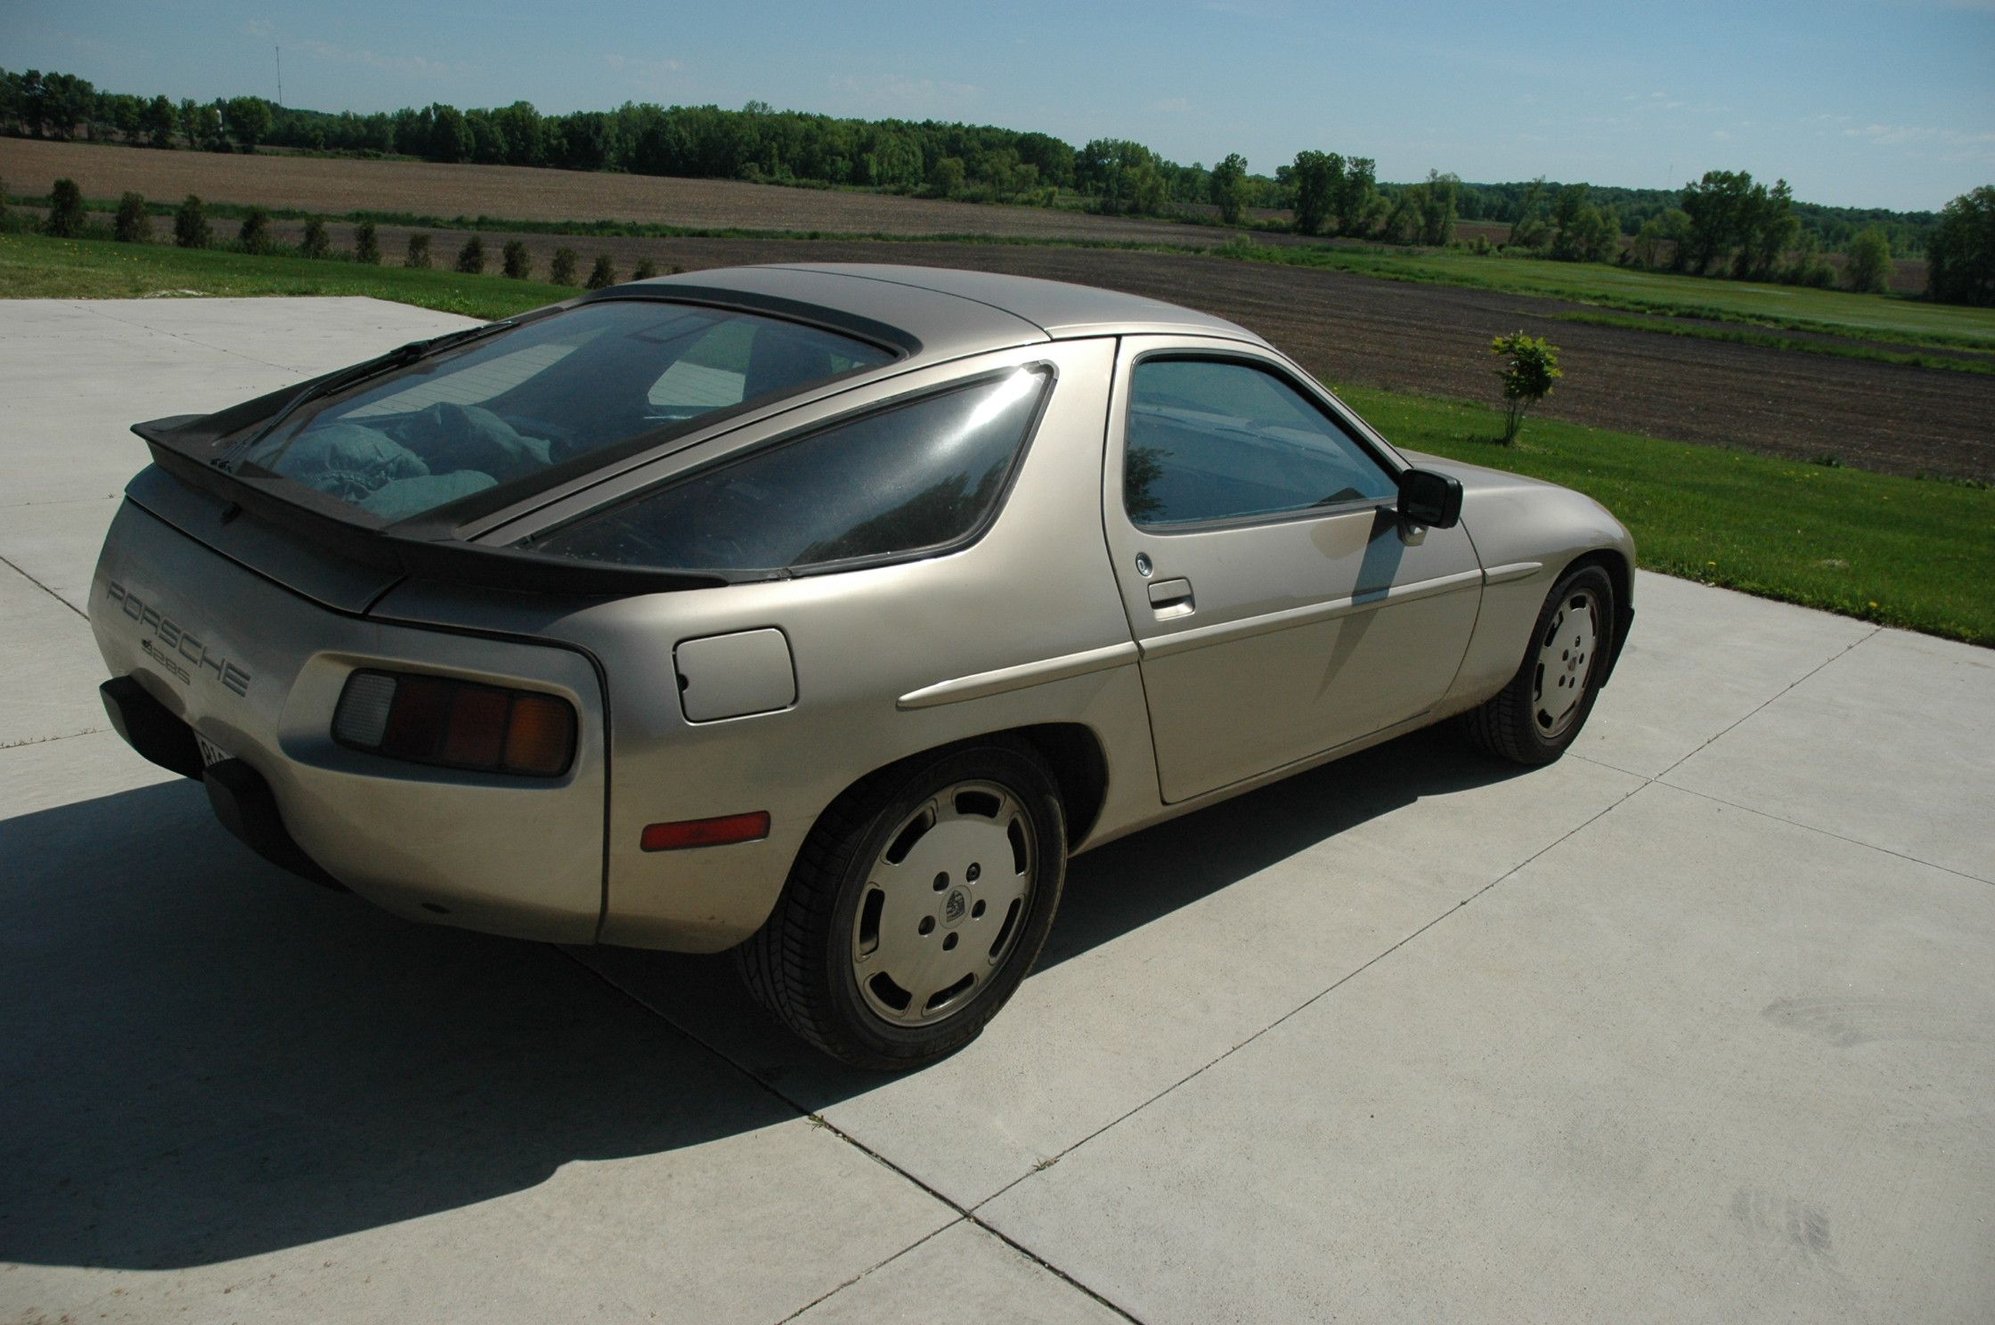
[{"x1": 1123, "y1": 357, "x2": 1397, "y2": 529}]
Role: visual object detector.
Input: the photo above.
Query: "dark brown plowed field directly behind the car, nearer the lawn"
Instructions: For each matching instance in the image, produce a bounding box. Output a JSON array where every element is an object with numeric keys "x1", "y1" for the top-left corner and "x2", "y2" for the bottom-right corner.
[{"x1": 359, "y1": 227, "x2": 1995, "y2": 481}]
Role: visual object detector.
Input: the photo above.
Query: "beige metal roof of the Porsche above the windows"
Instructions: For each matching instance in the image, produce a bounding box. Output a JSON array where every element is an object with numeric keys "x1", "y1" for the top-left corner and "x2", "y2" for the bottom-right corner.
[{"x1": 622, "y1": 261, "x2": 1265, "y2": 357}]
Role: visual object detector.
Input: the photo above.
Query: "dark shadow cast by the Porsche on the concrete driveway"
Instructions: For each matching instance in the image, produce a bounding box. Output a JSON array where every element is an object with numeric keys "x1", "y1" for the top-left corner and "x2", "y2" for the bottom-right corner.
[{"x1": 0, "y1": 734, "x2": 1512, "y2": 1269}]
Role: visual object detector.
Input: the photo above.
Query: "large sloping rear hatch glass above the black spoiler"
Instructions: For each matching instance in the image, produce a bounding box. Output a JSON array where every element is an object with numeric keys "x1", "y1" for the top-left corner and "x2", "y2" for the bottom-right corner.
[{"x1": 224, "y1": 299, "x2": 894, "y2": 523}]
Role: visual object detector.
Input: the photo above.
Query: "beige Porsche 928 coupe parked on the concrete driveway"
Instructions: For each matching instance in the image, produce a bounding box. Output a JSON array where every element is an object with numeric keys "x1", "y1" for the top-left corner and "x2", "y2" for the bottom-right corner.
[{"x1": 90, "y1": 265, "x2": 1634, "y2": 1068}]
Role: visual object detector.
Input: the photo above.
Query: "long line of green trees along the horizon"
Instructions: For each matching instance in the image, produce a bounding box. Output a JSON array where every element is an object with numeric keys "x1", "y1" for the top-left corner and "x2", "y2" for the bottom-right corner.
[{"x1": 0, "y1": 70, "x2": 1979, "y2": 297}]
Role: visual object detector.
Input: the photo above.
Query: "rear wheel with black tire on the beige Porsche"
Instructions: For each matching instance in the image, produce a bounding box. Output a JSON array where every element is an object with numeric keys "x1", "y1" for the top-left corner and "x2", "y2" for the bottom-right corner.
[{"x1": 734, "y1": 740, "x2": 1067, "y2": 1072}]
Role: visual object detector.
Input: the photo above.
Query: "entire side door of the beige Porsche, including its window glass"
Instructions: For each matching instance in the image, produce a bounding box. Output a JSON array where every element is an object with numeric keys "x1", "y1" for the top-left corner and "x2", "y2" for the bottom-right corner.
[{"x1": 1103, "y1": 337, "x2": 1482, "y2": 802}]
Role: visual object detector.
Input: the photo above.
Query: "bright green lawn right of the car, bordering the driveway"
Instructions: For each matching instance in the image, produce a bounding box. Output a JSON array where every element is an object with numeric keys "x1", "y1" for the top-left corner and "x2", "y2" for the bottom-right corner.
[{"x1": 1339, "y1": 387, "x2": 1995, "y2": 647}]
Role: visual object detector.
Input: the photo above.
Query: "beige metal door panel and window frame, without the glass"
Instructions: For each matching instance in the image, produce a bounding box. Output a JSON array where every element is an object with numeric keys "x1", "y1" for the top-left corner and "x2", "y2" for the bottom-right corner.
[{"x1": 1101, "y1": 335, "x2": 1482, "y2": 804}]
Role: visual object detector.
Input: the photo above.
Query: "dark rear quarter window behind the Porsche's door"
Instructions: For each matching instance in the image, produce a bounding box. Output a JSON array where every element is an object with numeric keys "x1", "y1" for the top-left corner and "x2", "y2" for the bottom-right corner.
[{"x1": 533, "y1": 369, "x2": 1051, "y2": 571}]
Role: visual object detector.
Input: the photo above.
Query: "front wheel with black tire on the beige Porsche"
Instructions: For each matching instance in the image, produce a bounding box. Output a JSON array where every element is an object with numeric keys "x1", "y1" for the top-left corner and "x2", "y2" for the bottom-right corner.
[{"x1": 1462, "y1": 565, "x2": 1616, "y2": 764}]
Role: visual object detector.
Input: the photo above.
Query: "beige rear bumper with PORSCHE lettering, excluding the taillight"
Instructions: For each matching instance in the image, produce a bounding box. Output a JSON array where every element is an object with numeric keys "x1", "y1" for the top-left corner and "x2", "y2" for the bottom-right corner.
[{"x1": 90, "y1": 501, "x2": 608, "y2": 944}]
